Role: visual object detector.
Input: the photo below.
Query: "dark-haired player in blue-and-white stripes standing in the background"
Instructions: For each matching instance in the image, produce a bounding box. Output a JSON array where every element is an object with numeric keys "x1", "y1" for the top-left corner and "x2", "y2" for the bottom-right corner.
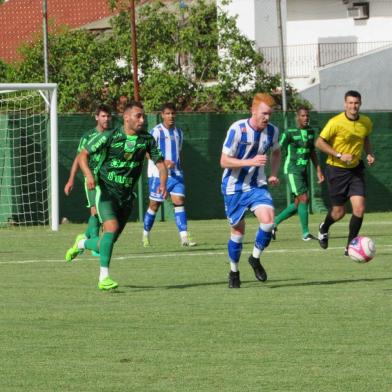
[{"x1": 143, "y1": 103, "x2": 196, "y2": 247}]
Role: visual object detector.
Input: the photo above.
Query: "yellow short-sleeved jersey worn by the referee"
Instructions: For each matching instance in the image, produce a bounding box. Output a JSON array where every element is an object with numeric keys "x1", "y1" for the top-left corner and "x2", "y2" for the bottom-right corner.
[{"x1": 320, "y1": 112, "x2": 373, "y2": 168}]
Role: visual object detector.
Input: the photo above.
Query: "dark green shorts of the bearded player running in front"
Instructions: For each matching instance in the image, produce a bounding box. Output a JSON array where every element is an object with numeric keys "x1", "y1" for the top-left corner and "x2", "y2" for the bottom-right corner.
[{"x1": 95, "y1": 185, "x2": 133, "y2": 232}]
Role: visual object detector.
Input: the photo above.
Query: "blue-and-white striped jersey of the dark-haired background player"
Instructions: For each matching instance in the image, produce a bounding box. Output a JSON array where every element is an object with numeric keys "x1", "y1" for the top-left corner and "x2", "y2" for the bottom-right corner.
[{"x1": 147, "y1": 123, "x2": 184, "y2": 177}]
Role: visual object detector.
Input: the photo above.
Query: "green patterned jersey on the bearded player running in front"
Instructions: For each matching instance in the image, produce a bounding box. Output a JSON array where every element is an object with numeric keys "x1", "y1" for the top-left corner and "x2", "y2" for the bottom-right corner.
[{"x1": 85, "y1": 127, "x2": 163, "y2": 203}]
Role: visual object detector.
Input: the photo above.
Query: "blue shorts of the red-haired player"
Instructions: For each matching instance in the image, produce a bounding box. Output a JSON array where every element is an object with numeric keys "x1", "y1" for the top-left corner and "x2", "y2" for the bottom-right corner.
[{"x1": 223, "y1": 186, "x2": 274, "y2": 226}]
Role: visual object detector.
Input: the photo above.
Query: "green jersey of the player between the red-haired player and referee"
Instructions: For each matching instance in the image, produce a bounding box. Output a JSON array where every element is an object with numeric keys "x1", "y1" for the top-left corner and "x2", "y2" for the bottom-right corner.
[{"x1": 279, "y1": 128, "x2": 315, "y2": 174}]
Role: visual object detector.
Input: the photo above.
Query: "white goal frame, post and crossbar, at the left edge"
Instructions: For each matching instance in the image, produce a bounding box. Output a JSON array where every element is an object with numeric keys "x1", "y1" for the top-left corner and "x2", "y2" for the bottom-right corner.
[{"x1": 0, "y1": 83, "x2": 59, "y2": 231}]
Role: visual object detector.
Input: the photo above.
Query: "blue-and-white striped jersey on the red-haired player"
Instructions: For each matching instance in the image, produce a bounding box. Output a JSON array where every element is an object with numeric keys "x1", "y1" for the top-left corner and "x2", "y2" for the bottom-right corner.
[{"x1": 222, "y1": 119, "x2": 280, "y2": 195}]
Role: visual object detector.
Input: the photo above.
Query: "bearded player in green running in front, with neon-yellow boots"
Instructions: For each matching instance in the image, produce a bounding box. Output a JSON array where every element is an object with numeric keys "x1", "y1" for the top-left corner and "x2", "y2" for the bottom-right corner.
[{"x1": 66, "y1": 101, "x2": 167, "y2": 290}]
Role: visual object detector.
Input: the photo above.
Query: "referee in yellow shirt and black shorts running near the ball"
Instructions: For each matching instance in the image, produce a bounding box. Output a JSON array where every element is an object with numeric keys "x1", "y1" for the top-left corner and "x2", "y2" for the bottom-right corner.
[{"x1": 316, "y1": 90, "x2": 375, "y2": 256}]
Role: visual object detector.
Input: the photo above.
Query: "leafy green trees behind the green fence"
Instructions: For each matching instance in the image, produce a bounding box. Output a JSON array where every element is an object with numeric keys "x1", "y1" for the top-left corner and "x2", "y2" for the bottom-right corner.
[{"x1": 0, "y1": 0, "x2": 308, "y2": 112}]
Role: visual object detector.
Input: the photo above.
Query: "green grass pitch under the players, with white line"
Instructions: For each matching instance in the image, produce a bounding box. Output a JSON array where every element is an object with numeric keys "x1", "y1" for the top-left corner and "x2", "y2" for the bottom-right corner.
[{"x1": 0, "y1": 213, "x2": 392, "y2": 392}]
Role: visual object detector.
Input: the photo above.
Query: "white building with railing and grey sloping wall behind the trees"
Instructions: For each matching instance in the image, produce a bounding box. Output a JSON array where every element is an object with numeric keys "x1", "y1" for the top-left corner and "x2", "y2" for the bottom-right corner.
[{"x1": 218, "y1": 0, "x2": 392, "y2": 110}]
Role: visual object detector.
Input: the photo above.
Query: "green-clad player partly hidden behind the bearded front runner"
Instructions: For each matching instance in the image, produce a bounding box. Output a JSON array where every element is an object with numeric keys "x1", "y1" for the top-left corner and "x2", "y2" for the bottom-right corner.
[{"x1": 64, "y1": 105, "x2": 111, "y2": 242}]
